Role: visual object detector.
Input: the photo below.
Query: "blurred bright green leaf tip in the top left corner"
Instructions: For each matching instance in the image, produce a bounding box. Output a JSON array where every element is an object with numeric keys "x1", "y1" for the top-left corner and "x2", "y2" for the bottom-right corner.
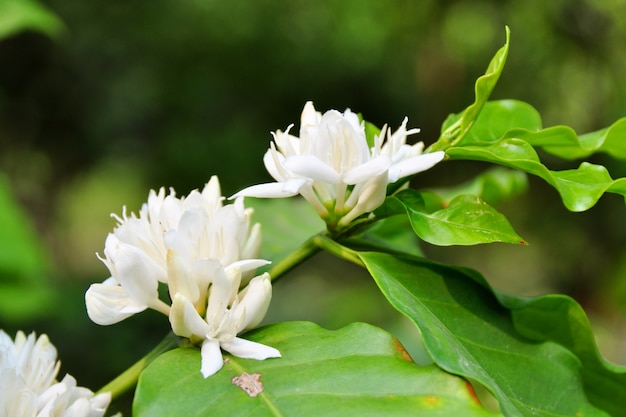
[{"x1": 0, "y1": 0, "x2": 64, "y2": 39}]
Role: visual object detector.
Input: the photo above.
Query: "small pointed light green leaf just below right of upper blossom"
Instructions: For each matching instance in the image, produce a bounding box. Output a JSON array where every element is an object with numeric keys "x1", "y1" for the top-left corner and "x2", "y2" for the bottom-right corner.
[{"x1": 390, "y1": 190, "x2": 526, "y2": 246}]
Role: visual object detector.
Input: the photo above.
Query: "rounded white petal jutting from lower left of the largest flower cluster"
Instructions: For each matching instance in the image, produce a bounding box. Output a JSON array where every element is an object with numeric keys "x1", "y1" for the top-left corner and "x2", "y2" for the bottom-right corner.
[{"x1": 85, "y1": 284, "x2": 147, "y2": 326}]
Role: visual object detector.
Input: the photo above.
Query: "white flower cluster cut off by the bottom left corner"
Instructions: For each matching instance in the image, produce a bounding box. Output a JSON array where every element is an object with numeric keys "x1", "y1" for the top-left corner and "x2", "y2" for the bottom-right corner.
[{"x1": 0, "y1": 330, "x2": 111, "y2": 417}]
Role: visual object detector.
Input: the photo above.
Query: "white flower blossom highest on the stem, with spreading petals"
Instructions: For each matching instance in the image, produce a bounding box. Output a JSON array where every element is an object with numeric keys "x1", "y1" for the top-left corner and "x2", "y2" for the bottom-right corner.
[{"x1": 232, "y1": 102, "x2": 444, "y2": 229}]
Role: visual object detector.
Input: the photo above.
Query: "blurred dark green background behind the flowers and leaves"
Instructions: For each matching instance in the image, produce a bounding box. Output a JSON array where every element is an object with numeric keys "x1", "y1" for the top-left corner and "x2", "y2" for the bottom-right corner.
[{"x1": 0, "y1": 0, "x2": 626, "y2": 410}]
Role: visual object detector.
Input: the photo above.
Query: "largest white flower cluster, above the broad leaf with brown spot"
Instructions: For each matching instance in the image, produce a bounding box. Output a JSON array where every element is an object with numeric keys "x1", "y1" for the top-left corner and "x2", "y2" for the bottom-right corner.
[{"x1": 85, "y1": 177, "x2": 280, "y2": 377}]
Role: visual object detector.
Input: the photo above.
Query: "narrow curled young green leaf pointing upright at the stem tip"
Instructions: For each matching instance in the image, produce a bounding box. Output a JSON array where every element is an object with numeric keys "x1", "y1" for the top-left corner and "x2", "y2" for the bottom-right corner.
[{"x1": 428, "y1": 27, "x2": 511, "y2": 152}]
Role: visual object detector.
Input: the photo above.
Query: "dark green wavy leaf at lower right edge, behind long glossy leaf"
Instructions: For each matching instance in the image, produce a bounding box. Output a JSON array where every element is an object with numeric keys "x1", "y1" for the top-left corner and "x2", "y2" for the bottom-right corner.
[{"x1": 498, "y1": 294, "x2": 626, "y2": 416}]
